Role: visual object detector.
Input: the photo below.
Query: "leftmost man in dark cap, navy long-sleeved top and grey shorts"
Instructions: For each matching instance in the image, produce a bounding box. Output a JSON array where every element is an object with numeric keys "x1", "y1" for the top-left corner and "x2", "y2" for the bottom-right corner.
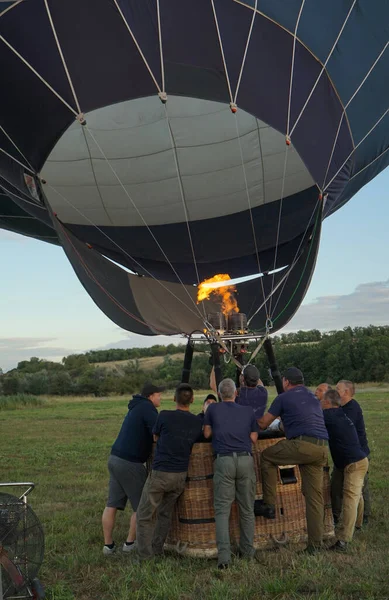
[{"x1": 102, "y1": 383, "x2": 164, "y2": 555}]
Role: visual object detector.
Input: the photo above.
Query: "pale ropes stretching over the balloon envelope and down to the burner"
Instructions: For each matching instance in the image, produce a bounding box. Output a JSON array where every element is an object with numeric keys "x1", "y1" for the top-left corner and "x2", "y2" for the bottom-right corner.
[{"x1": 0, "y1": 0, "x2": 389, "y2": 340}]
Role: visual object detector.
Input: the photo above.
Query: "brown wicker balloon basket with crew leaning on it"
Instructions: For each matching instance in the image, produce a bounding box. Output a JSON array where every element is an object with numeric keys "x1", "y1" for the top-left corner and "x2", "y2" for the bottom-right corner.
[{"x1": 161, "y1": 438, "x2": 334, "y2": 558}]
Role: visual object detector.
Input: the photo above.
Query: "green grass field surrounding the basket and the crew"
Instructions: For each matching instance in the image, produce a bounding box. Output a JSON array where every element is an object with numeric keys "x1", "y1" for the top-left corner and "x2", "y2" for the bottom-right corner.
[{"x1": 0, "y1": 385, "x2": 389, "y2": 600}]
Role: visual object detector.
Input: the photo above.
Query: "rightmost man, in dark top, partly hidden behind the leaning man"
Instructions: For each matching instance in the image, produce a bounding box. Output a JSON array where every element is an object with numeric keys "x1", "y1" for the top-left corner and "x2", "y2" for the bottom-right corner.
[{"x1": 331, "y1": 379, "x2": 371, "y2": 527}]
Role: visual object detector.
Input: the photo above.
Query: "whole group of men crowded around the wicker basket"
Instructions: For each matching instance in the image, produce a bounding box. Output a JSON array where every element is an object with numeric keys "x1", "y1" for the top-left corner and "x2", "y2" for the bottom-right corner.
[{"x1": 102, "y1": 365, "x2": 370, "y2": 569}]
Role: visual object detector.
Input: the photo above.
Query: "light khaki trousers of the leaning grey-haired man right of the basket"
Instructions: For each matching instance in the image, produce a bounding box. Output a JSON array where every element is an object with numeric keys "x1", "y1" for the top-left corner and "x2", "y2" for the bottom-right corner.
[{"x1": 338, "y1": 458, "x2": 369, "y2": 542}]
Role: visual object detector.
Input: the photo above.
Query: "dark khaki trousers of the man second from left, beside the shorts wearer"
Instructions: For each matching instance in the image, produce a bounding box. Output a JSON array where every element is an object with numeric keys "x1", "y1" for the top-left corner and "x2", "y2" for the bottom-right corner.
[{"x1": 136, "y1": 471, "x2": 187, "y2": 560}]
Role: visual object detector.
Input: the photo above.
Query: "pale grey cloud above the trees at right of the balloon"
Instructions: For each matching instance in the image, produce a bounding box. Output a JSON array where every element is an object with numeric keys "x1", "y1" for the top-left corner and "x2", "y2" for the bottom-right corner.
[{"x1": 284, "y1": 279, "x2": 389, "y2": 331}]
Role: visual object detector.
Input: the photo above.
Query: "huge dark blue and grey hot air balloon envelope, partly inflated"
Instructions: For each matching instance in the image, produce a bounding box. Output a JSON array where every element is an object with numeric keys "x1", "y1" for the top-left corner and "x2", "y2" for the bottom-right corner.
[{"x1": 0, "y1": 0, "x2": 389, "y2": 376}]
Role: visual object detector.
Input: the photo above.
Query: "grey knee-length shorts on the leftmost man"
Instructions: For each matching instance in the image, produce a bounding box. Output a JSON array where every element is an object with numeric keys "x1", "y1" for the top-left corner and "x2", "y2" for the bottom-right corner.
[{"x1": 107, "y1": 454, "x2": 147, "y2": 512}]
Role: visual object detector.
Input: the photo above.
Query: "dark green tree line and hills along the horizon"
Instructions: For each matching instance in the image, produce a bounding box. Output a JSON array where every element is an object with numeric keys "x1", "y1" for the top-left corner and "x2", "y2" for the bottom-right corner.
[{"x1": 0, "y1": 326, "x2": 389, "y2": 396}]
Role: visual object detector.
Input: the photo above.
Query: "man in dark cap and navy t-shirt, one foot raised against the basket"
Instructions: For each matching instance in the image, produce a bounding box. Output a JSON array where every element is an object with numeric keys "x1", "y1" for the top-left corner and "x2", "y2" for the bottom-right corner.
[{"x1": 256, "y1": 367, "x2": 328, "y2": 553}]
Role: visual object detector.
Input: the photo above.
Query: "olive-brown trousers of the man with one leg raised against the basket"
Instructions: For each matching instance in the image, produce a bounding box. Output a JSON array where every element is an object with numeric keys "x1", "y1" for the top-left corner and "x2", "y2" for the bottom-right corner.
[{"x1": 261, "y1": 440, "x2": 328, "y2": 545}]
